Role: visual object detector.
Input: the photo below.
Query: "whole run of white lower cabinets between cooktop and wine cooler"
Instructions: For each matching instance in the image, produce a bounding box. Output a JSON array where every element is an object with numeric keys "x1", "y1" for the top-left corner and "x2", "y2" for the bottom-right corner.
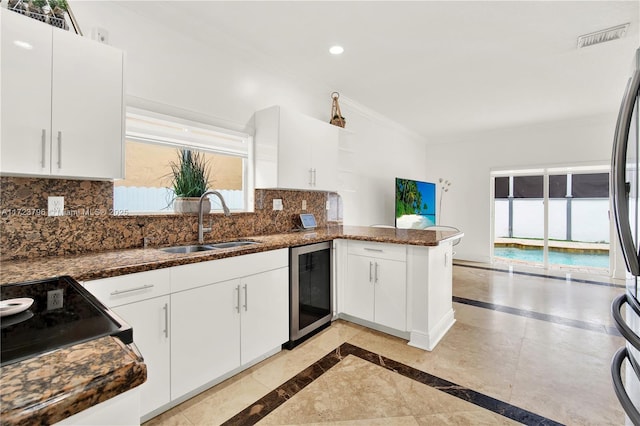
[{"x1": 84, "y1": 249, "x2": 289, "y2": 421}]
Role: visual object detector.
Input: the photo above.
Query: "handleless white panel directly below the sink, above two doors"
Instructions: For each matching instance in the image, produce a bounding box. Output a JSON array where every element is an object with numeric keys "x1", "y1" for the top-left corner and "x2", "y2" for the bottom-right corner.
[{"x1": 171, "y1": 249, "x2": 289, "y2": 293}]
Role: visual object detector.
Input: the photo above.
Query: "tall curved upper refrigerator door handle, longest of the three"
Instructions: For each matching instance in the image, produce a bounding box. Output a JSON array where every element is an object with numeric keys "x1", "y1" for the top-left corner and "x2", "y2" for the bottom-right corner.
[{"x1": 611, "y1": 70, "x2": 640, "y2": 276}]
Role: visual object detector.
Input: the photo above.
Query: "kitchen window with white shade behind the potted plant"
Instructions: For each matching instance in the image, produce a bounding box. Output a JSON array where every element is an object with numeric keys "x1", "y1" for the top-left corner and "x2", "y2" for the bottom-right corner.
[{"x1": 113, "y1": 109, "x2": 253, "y2": 213}]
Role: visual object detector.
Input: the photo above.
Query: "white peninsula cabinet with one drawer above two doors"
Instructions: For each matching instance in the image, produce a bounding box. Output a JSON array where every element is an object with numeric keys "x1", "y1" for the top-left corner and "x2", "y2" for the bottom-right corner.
[{"x1": 343, "y1": 241, "x2": 407, "y2": 331}]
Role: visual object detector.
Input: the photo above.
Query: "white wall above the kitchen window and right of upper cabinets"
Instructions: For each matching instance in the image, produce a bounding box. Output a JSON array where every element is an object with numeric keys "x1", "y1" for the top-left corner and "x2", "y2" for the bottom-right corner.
[{"x1": 70, "y1": 1, "x2": 426, "y2": 225}]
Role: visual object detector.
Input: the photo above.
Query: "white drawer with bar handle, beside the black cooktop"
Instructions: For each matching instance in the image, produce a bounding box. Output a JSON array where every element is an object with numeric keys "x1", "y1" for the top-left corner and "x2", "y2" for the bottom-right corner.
[{"x1": 84, "y1": 269, "x2": 171, "y2": 308}]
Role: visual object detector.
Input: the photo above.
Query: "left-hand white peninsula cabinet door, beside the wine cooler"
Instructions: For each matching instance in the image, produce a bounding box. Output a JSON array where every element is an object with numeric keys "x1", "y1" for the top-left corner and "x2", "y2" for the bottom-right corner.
[{"x1": 343, "y1": 255, "x2": 375, "y2": 321}]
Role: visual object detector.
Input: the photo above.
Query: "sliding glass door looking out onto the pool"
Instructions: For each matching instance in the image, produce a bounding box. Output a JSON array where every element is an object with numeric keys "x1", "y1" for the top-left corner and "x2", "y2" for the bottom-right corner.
[{"x1": 492, "y1": 168, "x2": 611, "y2": 273}]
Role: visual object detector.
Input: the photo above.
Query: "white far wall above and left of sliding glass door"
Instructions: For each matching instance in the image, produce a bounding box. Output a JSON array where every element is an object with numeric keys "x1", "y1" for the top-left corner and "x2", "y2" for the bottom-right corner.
[{"x1": 426, "y1": 112, "x2": 616, "y2": 262}]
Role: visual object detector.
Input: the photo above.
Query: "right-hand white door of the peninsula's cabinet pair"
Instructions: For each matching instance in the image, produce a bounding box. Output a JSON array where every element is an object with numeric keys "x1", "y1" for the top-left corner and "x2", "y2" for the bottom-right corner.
[{"x1": 373, "y1": 259, "x2": 407, "y2": 331}]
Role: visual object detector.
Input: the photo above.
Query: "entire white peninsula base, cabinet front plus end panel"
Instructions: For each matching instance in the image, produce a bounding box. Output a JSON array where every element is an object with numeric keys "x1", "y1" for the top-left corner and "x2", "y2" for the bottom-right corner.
[{"x1": 335, "y1": 240, "x2": 455, "y2": 351}]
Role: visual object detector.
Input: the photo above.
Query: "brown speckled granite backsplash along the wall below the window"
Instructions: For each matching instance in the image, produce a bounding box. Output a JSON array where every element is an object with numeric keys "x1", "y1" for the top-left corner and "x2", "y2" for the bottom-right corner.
[{"x1": 0, "y1": 177, "x2": 341, "y2": 260}]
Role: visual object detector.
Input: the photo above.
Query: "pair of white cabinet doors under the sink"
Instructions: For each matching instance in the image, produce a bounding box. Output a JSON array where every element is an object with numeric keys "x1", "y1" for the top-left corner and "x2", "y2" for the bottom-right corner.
[{"x1": 171, "y1": 265, "x2": 289, "y2": 399}]
